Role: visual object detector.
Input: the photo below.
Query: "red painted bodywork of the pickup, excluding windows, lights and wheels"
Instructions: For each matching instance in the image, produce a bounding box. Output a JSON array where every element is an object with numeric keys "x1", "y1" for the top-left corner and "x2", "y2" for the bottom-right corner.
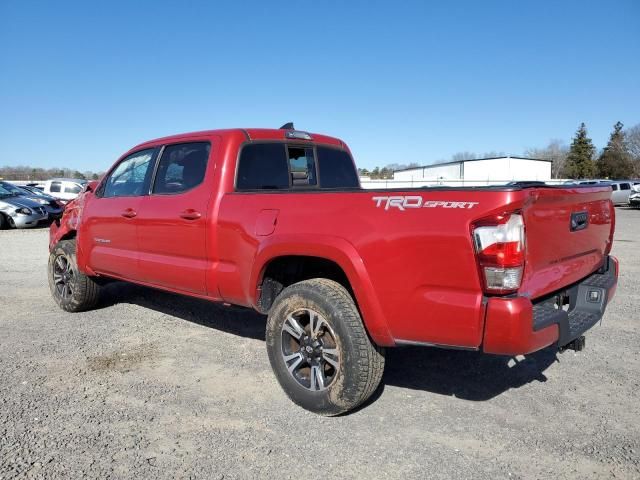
[{"x1": 50, "y1": 129, "x2": 615, "y2": 354}]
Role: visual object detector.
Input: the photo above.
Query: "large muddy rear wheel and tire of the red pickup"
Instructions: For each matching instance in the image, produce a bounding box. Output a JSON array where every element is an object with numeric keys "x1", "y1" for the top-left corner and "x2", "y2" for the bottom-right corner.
[{"x1": 266, "y1": 278, "x2": 384, "y2": 416}]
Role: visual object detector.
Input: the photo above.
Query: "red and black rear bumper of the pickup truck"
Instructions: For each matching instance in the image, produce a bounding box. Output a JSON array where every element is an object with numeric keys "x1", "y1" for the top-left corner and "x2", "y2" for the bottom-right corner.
[{"x1": 483, "y1": 257, "x2": 618, "y2": 355}]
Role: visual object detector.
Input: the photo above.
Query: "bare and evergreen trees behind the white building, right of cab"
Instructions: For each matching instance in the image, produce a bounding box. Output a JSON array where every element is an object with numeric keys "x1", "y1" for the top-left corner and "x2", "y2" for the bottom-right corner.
[{"x1": 358, "y1": 122, "x2": 640, "y2": 179}]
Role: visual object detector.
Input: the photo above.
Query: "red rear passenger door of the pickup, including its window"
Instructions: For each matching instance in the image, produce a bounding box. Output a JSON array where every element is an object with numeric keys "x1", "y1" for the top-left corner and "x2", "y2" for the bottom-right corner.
[{"x1": 138, "y1": 141, "x2": 214, "y2": 295}]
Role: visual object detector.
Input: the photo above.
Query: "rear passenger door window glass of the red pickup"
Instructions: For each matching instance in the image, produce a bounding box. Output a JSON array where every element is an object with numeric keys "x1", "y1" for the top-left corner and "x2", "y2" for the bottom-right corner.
[{"x1": 153, "y1": 142, "x2": 210, "y2": 194}]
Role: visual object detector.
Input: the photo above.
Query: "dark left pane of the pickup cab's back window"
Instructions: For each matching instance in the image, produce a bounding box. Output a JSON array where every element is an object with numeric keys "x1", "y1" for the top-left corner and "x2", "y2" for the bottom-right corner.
[{"x1": 236, "y1": 143, "x2": 289, "y2": 190}]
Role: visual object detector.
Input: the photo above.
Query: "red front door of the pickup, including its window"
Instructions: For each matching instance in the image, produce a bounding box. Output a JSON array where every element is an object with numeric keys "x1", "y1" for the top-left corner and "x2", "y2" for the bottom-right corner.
[{"x1": 81, "y1": 148, "x2": 157, "y2": 280}]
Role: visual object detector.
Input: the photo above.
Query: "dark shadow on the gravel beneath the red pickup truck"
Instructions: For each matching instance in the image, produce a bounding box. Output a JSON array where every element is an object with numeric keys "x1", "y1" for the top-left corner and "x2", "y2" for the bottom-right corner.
[{"x1": 100, "y1": 282, "x2": 558, "y2": 407}]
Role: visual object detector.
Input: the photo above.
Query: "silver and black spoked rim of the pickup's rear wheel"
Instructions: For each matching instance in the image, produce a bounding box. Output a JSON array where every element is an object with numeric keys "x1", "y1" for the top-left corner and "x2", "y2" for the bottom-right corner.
[{"x1": 282, "y1": 308, "x2": 340, "y2": 392}]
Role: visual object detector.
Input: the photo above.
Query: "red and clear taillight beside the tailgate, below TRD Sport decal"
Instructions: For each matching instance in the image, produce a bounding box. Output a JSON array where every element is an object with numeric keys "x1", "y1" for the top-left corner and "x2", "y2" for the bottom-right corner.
[{"x1": 473, "y1": 213, "x2": 525, "y2": 294}]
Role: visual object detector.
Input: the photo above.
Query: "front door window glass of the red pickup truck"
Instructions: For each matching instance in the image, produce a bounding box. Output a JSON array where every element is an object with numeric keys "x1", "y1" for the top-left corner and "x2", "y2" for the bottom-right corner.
[{"x1": 102, "y1": 148, "x2": 155, "y2": 197}]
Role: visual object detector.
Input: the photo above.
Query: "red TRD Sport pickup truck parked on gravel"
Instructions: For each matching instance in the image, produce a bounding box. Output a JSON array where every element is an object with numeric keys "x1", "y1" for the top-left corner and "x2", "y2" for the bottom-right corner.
[{"x1": 48, "y1": 125, "x2": 618, "y2": 415}]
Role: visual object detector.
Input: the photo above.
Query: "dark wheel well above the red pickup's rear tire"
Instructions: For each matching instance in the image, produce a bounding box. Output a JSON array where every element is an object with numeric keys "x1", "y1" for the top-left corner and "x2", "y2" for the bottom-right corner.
[{"x1": 257, "y1": 255, "x2": 355, "y2": 314}]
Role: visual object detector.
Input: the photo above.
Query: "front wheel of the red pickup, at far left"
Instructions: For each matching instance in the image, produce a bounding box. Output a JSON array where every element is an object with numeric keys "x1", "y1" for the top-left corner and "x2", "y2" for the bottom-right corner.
[{"x1": 47, "y1": 240, "x2": 100, "y2": 312}]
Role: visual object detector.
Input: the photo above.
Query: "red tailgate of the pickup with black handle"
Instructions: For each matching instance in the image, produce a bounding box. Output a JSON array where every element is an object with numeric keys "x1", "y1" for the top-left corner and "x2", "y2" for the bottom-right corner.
[{"x1": 520, "y1": 187, "x2": 615, "y2": 299}]
